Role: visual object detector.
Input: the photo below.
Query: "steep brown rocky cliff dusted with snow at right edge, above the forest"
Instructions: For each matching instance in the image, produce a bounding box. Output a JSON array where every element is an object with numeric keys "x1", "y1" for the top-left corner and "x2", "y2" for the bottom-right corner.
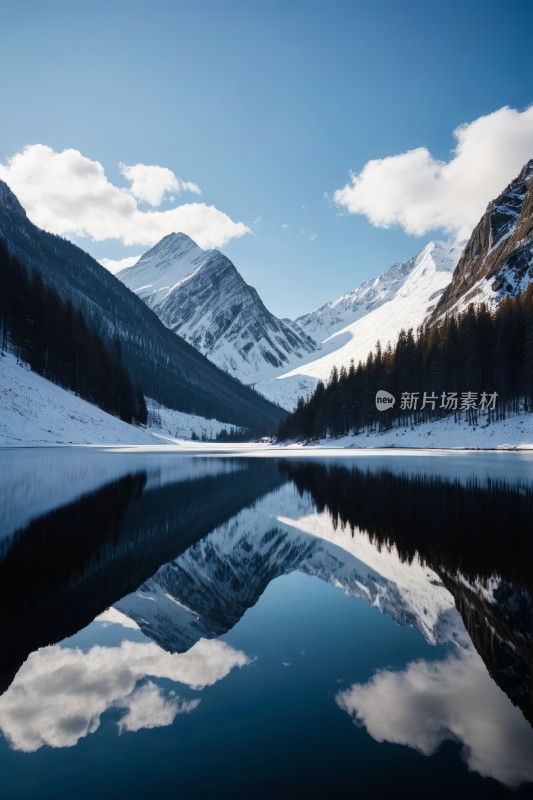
[{"x1": 428, "y1": 159, "x2": 533, "y2": 325}]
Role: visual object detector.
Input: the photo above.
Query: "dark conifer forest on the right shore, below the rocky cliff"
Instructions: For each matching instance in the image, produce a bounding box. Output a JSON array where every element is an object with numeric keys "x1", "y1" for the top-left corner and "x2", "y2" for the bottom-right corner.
[{"x1": 279, "y1": 285, "x2": 533, "y2": 440}]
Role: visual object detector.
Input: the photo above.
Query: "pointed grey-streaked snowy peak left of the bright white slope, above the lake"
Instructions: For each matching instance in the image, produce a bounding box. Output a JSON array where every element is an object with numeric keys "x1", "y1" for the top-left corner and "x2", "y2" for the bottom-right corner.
[{"x1": 117, "y1": 233, "x2": 316, "y2": 383}]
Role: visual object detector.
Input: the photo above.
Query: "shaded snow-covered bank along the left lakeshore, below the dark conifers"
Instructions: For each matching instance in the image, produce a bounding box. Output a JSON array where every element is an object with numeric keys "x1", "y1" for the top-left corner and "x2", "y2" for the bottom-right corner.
[{"x1": 0, "y1": 353, "x2": 235, "y2": 446}]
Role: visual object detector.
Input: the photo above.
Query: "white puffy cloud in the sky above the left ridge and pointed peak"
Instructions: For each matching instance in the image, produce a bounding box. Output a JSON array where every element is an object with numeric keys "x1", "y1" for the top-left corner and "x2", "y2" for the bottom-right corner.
[{"x1": 0, "y1": 144, "x2": 249, "y2": 248}]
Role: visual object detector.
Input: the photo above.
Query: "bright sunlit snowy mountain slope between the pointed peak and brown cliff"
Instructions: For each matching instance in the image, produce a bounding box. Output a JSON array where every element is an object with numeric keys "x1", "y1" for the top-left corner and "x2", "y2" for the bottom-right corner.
[{"x1": 255, "y1": 242, "x2": 460, "y2": 409}]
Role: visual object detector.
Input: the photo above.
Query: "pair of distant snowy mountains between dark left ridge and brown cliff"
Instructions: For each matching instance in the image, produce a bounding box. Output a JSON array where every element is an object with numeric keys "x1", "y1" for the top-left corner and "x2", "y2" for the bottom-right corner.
[{"x1": 117, "y1": 233, "x2": 459, "y2": 409}]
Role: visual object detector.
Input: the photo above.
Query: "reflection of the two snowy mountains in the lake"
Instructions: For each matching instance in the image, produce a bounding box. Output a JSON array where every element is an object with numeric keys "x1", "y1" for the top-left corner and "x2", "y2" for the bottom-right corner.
[{"x1": 115, "y1": 484, "x2": 461, "y2": 652}]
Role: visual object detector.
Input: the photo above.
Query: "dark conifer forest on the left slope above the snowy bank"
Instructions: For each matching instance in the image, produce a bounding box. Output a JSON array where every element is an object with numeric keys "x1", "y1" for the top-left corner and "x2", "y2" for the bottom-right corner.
[{"x1": 0, "y1": 239, "x2": 147, "y2": 424}]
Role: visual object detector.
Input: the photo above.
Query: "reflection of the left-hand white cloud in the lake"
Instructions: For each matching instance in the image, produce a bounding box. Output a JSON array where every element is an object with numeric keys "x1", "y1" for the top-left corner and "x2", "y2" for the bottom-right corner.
[{"x1": 0, "y1": 636, "x2": 250, "y2": 753}]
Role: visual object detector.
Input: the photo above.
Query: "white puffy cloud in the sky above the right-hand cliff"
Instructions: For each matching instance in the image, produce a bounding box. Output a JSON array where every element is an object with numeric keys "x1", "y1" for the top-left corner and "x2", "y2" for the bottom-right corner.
[{"x1": 334, "y1": 106, "x2": 533, "y2": 240}]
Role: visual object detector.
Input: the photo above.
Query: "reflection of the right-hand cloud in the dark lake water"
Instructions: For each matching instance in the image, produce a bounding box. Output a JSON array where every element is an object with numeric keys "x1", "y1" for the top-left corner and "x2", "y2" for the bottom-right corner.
[{"x1": 335, "y1": 648, "x2": 533, "y2": 787}]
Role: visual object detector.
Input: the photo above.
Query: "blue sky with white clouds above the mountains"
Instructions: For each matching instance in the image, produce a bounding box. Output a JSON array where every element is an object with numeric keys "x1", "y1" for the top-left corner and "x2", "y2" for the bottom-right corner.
[{"x1": 0, "y1": 0, "x2": 533, "y2": 318}]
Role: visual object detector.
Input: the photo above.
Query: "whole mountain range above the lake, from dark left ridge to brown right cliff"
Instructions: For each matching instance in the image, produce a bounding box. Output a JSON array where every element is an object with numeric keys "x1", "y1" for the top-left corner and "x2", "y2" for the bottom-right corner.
[{"x1": 0, "y1": 160, "x2": 533, "y2": 430}]
